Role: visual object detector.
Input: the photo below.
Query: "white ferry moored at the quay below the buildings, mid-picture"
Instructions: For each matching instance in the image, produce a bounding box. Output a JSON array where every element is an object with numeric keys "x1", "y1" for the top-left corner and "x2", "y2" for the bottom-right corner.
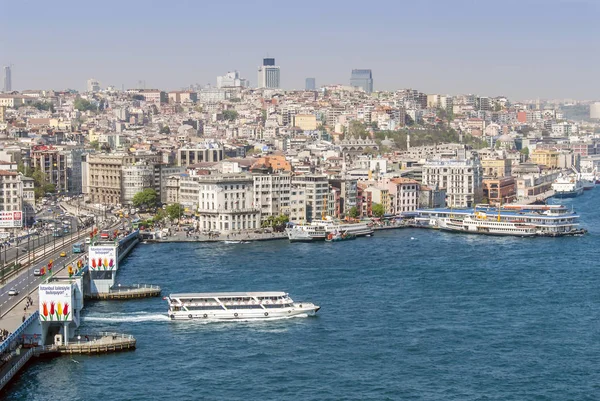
[{"x1": 285, "y1": 217, "x2": 373, "y2": 242}]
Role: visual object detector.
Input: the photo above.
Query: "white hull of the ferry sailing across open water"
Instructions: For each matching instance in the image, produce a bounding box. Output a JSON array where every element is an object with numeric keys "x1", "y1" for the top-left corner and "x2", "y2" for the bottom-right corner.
[{"x1": 168, "y1": 302, "x2": 321, "y2": 321}]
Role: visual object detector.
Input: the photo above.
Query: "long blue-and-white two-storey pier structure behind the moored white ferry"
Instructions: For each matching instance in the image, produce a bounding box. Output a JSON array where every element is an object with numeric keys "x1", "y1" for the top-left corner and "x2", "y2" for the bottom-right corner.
[{"x1": 417, "y1": 204, "x2": 585, "y2": 237}]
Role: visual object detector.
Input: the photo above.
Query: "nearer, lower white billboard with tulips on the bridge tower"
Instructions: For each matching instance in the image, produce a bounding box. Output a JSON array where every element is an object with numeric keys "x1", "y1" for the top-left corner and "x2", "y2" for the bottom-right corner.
[{"x1": 39, "y1": 284, "x2": 73, "y2": 322}]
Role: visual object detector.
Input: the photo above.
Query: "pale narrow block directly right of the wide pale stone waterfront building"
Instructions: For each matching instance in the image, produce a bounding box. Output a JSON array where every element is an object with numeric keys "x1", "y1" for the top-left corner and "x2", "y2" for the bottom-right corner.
[{"x1": 253, "y1": 173, "x2": 292, "y2": 221}]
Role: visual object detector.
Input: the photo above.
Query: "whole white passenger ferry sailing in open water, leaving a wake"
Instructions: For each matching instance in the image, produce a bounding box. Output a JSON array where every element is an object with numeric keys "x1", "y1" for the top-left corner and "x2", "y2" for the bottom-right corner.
[{"x1": 164, "y1": 292, "x2": 321, "y2": 321}]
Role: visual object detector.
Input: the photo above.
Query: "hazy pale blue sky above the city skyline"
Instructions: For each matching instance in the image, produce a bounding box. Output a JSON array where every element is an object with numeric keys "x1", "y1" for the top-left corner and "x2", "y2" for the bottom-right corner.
[{"x1": 0, "y1": 0, "x2": 600, "y2": 99}]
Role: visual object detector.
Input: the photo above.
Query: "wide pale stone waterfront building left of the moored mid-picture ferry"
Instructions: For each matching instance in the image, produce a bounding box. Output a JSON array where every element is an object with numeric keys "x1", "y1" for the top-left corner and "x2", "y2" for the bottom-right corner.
[{"x1": 198, "y1": 174, "x2": 261, "y2": 233}]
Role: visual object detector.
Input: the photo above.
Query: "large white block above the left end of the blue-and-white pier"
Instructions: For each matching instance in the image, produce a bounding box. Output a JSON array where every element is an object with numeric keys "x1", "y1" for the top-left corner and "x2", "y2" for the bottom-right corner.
[{"x1": 423, "y1": 158, "x2": 483, "y2": 208}]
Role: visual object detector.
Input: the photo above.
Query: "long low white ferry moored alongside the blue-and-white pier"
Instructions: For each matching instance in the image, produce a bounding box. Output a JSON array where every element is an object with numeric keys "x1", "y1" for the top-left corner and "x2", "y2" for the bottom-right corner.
[{"x1": 438, "y1": 216, "x2": 538, "y2": 237}]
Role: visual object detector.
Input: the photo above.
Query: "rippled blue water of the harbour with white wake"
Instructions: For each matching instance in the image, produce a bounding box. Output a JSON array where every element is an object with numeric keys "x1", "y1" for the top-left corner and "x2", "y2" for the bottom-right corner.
[{"x1": 6, "y1": 189, "x2": 600, "y2": 401}]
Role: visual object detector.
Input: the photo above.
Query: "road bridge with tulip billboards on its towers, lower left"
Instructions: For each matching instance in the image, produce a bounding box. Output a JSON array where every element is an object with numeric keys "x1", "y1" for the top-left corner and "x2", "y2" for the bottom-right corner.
[{"x1": 0, "y1": 231, "x2": 156, "y2": 389}]
